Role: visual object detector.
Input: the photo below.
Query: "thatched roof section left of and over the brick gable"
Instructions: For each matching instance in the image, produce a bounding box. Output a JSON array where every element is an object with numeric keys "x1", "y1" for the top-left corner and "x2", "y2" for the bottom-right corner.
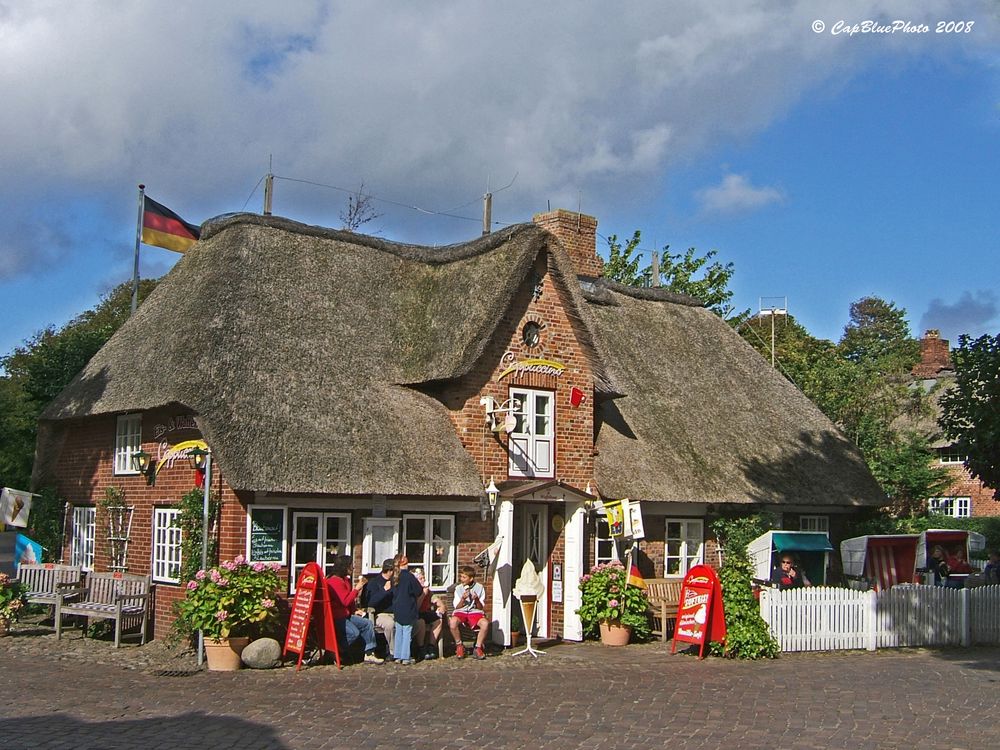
[{"x1": 43, "y1": 214, "x2": 615, "y2": 496}]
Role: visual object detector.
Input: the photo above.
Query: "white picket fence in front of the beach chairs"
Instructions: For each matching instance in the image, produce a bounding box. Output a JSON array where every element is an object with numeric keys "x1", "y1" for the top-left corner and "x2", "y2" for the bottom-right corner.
[{"x1": 760, "y1": 585, "x2": 1000, "y2": 651}]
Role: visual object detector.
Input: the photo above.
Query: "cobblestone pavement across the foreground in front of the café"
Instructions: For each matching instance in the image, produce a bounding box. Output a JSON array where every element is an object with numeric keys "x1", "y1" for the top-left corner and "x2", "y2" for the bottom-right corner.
[{"x1": 0, "y1": 625, "x2": 1000, "y2": 750}]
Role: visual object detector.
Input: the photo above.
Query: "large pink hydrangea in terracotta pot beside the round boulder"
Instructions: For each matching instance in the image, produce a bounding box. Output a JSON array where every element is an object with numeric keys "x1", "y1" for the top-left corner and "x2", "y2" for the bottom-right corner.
[{"x1": 174, "y1": 555, "x2": 281, "y2": 670}]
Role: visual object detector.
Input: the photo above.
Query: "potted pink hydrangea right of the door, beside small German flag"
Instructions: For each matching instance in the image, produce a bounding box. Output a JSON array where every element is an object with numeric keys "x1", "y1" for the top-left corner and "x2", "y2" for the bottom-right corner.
[{"x1": 576, "y1": 561, "x2": 649, "y2": 646}]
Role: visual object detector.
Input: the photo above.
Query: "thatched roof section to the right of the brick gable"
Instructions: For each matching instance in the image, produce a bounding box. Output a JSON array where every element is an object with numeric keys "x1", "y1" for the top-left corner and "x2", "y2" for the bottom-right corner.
[{"x1": 587, "y1": 282, "x2": 885, "y2": 505}]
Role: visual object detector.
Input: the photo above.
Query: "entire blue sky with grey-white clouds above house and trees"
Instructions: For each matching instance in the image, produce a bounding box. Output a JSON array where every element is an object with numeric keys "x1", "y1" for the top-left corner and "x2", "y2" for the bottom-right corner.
[{"x1": 0, "y1": 0, "x2": 1000, "y2": 362}]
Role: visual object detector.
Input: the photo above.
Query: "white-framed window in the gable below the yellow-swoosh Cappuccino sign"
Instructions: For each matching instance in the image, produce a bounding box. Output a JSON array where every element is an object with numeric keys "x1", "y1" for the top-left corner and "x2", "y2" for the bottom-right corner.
[{"x1": 507, "y1": 388, "x2": 556, "y2": 477}]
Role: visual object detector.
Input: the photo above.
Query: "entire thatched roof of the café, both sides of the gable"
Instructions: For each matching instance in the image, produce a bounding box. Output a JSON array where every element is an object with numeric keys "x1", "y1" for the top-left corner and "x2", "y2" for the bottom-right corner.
[{"x1": 36, "y1": 209, "x2": 883, "y2": 505}]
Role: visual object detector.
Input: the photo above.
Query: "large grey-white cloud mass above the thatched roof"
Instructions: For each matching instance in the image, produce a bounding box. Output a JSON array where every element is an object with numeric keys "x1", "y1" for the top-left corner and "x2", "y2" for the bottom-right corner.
[{"x1": 0, "y1": 0, "x2": 996, "y2": 256}]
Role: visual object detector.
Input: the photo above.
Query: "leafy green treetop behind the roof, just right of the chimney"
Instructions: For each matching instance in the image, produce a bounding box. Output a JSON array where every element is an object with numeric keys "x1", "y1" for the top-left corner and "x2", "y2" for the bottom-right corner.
[{"x1": 604, "y1": 229, "x2": 747, "y2": 322}]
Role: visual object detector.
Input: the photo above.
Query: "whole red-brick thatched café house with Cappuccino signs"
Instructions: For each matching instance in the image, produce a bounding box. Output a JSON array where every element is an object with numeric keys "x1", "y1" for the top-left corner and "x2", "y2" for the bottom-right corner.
[{"x1": 34, "y1": 210, "x2": 885, "y2": 643}]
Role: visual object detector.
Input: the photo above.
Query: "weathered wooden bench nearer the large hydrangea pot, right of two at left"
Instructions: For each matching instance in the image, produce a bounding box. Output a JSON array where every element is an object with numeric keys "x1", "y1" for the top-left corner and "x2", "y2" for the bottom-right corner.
[{"x1": 56, "y1": 573, "x2": 150, "y2": 648}]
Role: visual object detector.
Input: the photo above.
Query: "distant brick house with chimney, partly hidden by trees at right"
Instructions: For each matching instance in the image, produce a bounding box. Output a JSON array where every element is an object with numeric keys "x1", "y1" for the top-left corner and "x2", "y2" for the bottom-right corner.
[{"x1": 912, "y1": 329, "x2": 1000, "y2": 518}]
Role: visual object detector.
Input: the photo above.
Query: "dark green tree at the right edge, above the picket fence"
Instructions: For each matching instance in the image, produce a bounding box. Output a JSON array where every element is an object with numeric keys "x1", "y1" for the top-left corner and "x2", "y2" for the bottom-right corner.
[{"x1": 940, "y1": 335, "x2": 1000, "y2": 500}]
